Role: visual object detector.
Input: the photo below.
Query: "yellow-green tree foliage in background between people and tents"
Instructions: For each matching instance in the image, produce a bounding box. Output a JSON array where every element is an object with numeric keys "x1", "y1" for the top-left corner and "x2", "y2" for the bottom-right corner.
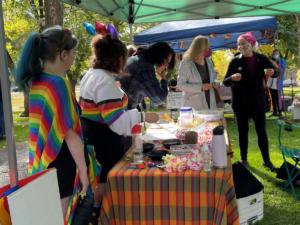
[{"x1": 3, "y1": 0, "x2": 298, "y2": 80}]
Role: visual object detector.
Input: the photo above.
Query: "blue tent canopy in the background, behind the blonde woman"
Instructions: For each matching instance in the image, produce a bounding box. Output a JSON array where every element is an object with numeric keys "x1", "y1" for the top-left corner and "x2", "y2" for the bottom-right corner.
[{"x1": 134, "y1": 16, "x2": 277, "y2": 52}]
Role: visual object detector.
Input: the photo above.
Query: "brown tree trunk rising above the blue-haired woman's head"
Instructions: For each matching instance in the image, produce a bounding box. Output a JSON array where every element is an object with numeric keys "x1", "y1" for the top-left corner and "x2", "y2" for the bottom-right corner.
[{"x1": 44, "y1": 0, "x2": 64, "y2": 27}]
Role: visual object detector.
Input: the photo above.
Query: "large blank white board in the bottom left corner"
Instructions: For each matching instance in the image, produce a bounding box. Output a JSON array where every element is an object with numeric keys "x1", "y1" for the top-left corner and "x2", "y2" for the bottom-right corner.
[{"x1": 7, "y1": 169, "x2": 64, "y2": 225}]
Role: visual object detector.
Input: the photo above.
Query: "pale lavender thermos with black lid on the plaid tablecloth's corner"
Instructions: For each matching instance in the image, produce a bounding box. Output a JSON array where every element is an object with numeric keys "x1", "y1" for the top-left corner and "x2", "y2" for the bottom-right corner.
[{"x1": 212, "y1": 126, "x2": 227, "y2": 168}]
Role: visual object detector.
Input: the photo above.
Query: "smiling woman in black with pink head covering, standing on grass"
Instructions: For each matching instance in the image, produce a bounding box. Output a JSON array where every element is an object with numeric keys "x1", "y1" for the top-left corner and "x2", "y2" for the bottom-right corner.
[{"x1": 223, "y1": 32, "x2": 276, "y2": 171}]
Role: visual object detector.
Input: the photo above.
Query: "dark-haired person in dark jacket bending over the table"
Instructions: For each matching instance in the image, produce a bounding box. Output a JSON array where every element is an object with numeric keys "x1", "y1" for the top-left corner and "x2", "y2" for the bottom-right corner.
[{"x1": 121, "y1": 42, "x2": 173, "y2": 109}]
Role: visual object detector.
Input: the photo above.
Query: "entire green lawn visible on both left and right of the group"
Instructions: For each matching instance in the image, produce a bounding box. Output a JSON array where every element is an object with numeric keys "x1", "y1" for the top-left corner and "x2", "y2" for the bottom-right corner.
[{"x1": 0, "y1": 88, "x2": 300, "y2": 225}]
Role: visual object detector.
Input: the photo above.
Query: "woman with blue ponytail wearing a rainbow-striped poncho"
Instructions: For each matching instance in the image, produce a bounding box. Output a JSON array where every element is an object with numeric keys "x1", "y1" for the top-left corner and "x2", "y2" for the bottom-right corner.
[{"x1": 15, "y1": 26, "x2": 89, "y2": 215}]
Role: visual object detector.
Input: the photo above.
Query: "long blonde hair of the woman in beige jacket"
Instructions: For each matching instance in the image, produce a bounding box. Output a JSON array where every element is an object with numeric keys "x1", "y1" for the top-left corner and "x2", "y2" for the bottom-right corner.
[{"x1": 183, "y1": 35, "x2": 209, "y2": 61}]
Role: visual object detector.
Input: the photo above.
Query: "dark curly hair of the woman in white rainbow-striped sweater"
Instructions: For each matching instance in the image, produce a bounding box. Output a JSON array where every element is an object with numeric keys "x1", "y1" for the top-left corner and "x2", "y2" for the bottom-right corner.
[{"x1": 91, "y1": 34, "x2": 127, "y2": 73}]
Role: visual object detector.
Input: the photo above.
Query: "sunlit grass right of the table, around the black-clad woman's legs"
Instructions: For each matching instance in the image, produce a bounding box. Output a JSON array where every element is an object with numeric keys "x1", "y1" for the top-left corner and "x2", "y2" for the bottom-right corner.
[{"x1": 226, "y1": 114, "x2": 300, "y2": 225}]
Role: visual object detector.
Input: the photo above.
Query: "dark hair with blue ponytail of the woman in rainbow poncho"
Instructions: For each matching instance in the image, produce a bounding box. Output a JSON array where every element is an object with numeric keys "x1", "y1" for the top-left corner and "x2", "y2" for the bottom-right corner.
[{"x1": 14, "y1": 26, "x2": 77, "y2": 90}]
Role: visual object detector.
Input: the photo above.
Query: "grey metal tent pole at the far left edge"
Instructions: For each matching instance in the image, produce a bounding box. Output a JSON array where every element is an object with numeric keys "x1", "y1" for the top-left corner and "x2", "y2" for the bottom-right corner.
[{"x1": 0, "y1": 1, "x2": 18, "y2": 187}]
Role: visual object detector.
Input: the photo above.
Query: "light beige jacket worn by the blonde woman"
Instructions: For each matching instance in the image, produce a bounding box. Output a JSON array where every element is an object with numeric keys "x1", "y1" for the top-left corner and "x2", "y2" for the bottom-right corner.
[{"x1": 177, "y1": 58, "x2": 217, "y2": 110}]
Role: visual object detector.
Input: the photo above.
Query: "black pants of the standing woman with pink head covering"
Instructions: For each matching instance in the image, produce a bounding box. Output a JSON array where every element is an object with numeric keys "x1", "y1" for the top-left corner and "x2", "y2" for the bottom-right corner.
[{"x1": 234, "y1": 106, "x2": 270, "y2": 162}]
